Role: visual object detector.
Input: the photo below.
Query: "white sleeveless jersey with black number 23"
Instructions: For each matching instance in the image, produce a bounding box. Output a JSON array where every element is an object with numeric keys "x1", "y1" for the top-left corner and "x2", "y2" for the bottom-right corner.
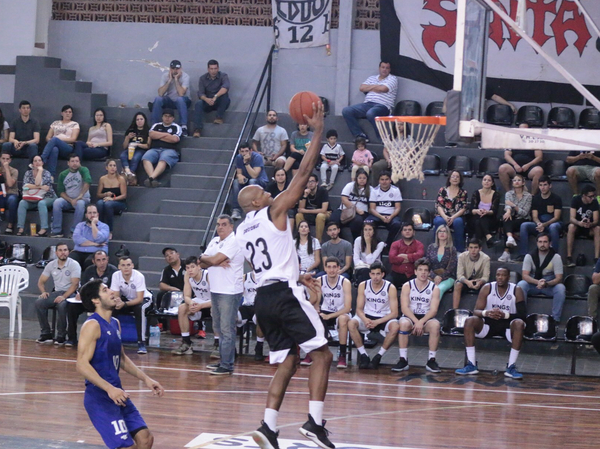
[{"x1": 235, "y1": 207, "x2": 300, "y2": 287}]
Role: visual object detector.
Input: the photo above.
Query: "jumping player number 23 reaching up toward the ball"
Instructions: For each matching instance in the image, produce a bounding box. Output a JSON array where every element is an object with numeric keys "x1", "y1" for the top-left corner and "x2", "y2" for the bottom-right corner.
[{"x1": 236, "y1": 102, "x2": 335, "y2": 449}]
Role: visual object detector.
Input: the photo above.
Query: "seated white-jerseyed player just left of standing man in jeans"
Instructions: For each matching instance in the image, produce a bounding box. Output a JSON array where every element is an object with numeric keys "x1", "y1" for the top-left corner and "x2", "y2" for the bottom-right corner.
[{"x1": 172, "y1": 256, "x2": 212, "y2": 355}]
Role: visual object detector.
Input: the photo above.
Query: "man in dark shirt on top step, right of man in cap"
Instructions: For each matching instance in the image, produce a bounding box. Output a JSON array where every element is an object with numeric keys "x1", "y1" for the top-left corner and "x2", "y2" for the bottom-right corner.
[{"x1": 194, "y1": 59, "x2": 231, "y2": 137}]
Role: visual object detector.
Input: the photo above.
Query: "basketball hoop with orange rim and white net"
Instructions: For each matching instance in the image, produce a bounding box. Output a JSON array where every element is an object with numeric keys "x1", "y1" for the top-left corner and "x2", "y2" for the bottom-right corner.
[{"x1": 375, "y1": 116, "x2": 446, "y2": 182}]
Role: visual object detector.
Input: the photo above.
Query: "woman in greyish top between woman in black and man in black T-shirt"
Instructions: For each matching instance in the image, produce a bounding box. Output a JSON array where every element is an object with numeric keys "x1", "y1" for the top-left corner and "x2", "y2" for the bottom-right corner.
[{"x1": 498, "y1": 173, "x2": 533, "y2": 263}]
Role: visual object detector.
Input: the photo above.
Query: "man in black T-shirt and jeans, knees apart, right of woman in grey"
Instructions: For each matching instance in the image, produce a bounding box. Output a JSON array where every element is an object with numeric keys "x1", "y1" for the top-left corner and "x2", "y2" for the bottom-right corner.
[{"x1": 515, "y1": 175, "x2": 562, "y2": 262}]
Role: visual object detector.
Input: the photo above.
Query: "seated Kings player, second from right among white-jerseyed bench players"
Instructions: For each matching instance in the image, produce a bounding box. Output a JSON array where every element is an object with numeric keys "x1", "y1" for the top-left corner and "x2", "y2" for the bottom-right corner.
[{"x1": 392, "y1": 257, "x2": 441, "y2": 373}]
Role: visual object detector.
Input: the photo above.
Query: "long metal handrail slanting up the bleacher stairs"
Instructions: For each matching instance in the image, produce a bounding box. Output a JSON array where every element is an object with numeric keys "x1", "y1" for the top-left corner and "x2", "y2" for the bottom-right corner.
[{"x1": 200, "y1": 45, "x2": 275, "y2": 251}]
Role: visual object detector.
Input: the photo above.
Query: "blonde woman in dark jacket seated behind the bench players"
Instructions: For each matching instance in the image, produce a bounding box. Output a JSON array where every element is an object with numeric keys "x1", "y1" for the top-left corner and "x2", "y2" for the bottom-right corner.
[{"x1": 425, "y1": 225, "x2": 458, "y2": 299}]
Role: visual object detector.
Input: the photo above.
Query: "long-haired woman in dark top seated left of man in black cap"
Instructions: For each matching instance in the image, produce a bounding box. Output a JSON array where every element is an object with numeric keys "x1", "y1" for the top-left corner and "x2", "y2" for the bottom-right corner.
[{"x1": 121, "y1": 112, "x2": 152, "y2": 186}]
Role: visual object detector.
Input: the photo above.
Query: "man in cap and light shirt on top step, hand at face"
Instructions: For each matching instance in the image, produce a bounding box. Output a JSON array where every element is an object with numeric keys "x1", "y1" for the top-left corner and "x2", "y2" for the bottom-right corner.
[{"x1": 148, "y1": 59, "x2": 192, "y2": 137}]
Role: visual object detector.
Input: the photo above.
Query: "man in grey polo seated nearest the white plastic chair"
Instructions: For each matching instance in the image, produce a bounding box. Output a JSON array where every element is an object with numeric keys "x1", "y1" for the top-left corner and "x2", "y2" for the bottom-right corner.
[{"x1": 35, "y1": 242, "x2": 81, "y2": 346}]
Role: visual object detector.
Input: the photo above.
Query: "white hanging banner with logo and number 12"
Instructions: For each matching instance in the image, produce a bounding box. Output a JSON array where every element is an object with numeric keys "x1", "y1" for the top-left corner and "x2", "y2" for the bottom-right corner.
[{"x1": 272, "y1": 0, "x2": 332, "y2": 48}]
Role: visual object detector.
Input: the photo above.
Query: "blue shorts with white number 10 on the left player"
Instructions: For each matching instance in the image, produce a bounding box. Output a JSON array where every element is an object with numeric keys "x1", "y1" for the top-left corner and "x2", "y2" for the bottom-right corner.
[{"x1": 83, "y1": 387, "x2": 148, "y2": 449}]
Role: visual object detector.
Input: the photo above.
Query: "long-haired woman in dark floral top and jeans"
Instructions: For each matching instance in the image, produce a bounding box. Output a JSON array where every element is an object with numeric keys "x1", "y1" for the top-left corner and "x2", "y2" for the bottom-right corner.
[{"x1": 433, "y1": 170, "x2": 467, "y2": 252}]
